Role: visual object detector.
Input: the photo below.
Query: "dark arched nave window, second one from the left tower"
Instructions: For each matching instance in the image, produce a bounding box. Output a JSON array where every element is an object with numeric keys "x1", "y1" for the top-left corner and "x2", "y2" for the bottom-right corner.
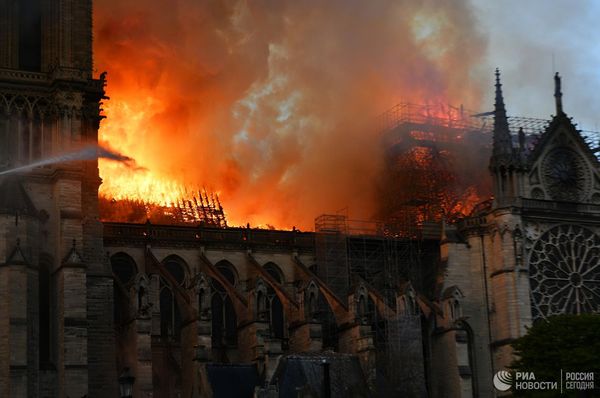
[{"x1": 160, "y1": 258, "x2": 185, "y2": 341}]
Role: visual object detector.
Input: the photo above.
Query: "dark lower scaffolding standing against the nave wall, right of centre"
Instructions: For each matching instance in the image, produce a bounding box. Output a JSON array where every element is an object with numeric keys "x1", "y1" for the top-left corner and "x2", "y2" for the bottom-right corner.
[{"x1": 315, "y1": 215, "x2": 439, "y2": 393}]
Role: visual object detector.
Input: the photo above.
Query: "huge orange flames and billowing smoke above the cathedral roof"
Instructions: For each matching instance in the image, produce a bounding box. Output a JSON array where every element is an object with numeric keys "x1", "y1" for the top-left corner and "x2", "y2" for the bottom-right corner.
[{"x1": 94, "y1": 0, "x2": 484, "y2": 229}]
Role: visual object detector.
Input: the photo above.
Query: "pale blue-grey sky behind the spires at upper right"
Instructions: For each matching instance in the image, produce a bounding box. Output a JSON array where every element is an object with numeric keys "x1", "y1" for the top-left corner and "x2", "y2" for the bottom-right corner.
[{"x1": 473, "y1": 0, "x2": 600, "y2": 131}]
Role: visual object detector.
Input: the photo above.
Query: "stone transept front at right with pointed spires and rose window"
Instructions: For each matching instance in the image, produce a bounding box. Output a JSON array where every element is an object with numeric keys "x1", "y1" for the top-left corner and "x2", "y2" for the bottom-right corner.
[{"x1": 440, "y1": 71, "x2": 600, "y2": 397}]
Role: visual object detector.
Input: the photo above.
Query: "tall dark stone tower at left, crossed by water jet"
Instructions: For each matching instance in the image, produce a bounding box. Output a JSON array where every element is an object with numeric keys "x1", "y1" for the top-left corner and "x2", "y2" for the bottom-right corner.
[{"x1": 0, "y1": 0, "x2": 117, "y2": 397}]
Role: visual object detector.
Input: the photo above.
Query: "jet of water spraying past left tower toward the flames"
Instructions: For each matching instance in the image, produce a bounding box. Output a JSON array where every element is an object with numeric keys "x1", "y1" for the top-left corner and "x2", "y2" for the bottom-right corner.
[{"x1": 0, "y1": 145, "x2": 144, "y2": 176}]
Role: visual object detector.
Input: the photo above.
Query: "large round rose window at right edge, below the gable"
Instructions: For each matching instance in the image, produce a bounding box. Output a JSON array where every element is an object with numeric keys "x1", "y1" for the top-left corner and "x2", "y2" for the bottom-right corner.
[{"x1": 529, "y1": 225, "x2": 600, "y2": 318}]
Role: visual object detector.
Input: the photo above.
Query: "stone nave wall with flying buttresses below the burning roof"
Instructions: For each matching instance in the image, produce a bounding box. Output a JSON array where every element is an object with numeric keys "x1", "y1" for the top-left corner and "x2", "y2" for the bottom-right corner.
[{"x1": 104, "y1": 223, "x2": 436, "y2": 397}]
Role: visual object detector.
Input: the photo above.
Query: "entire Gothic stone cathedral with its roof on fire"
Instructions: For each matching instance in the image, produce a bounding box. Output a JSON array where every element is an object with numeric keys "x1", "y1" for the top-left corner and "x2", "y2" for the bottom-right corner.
[{"x1": 0, "y1": 0, "x2": 600, "y2": 397}]
